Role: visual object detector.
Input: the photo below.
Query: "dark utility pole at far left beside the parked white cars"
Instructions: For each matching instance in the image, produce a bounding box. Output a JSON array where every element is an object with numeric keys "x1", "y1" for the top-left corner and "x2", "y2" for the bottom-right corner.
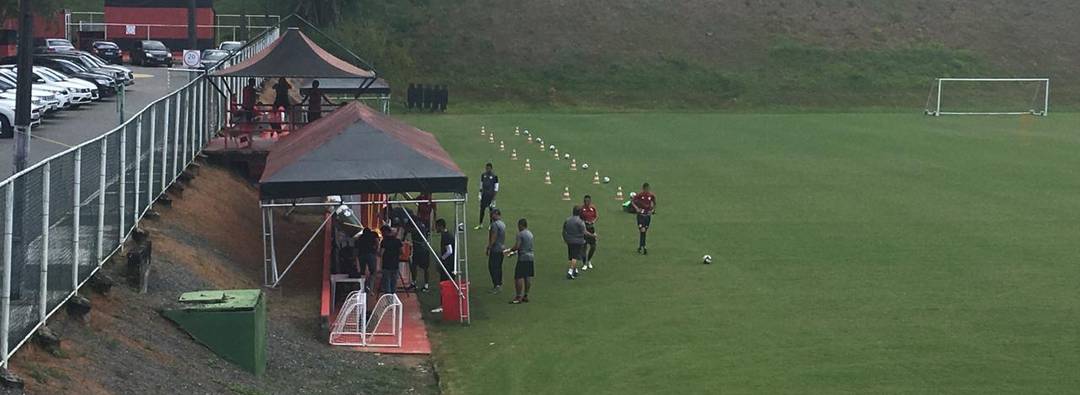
[{"x1": 14, "y1": 0, "x2": 33, "y2": 173}]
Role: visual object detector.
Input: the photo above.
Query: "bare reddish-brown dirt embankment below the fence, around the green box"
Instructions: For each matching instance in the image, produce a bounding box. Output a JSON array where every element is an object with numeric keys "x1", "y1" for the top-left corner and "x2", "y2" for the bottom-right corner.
[{"x1": 3, "y1": 165, "x2": 437, "y2": 394}]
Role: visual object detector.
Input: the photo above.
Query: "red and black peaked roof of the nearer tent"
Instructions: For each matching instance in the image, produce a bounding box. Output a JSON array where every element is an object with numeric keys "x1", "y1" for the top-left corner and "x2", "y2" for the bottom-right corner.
[{"x1": 259, "y1": 101, "x2": 468, "y2": 199}]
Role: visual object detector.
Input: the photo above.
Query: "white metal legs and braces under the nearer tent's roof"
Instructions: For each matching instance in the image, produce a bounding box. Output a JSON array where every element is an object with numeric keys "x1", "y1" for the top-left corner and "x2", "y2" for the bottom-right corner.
[{"x1": 259, "y1": 193, "x2": 472, "y2": 324}]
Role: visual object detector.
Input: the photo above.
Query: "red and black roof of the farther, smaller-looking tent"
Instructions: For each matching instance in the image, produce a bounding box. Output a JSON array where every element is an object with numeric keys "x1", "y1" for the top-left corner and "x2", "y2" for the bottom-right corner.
[{"x1": 214, "y1": 27, "x2": 375, "y2": 78}]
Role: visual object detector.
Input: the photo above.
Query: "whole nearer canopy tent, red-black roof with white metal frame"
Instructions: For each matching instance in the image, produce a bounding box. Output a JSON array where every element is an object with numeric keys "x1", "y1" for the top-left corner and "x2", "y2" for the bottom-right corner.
[{"x1": 259, "y1": 101, "x2": 469, "y2": 322}]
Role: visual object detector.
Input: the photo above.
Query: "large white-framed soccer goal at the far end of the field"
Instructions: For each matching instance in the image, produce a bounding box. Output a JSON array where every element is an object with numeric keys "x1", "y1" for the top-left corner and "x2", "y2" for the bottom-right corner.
[{"x1": 927, "y1": 78, "x2": 1050, "y2": 117}]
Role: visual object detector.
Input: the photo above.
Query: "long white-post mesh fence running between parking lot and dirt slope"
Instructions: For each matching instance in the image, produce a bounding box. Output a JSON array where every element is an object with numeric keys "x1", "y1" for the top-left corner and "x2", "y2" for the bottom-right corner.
[{"x1": 0, "y1": 29, "x2": 279, "y2": 368}]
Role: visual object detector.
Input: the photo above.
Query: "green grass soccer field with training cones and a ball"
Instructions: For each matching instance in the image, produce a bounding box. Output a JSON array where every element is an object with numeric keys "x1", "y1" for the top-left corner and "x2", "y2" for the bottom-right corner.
[{"x1": 405, "y1": 113, "x2": 1080, "y2": 394}]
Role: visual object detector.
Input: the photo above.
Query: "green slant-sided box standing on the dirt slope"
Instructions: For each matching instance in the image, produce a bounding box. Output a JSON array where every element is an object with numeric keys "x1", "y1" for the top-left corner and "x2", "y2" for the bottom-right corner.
[{"x1": 162, "y1": 289, "x2": 267, "y2": 376}]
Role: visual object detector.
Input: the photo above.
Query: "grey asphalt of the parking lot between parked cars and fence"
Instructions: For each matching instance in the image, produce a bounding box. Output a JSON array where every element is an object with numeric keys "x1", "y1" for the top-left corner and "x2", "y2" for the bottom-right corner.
[{"x1": 0, "y1": 67, "x2": 188, "y2": 179}]
